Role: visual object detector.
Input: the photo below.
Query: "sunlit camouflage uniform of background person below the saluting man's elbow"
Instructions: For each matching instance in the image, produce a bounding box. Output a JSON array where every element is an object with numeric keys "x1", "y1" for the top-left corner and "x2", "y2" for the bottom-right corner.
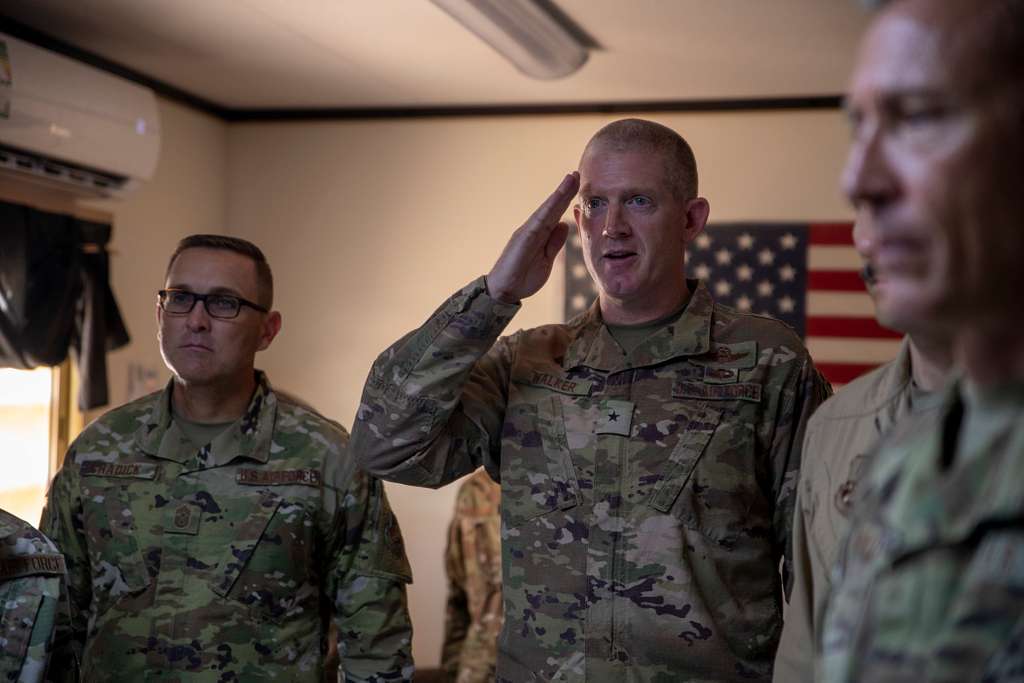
[{"x1": 441, "y1": 470, "x2": 504, "y2": 683}]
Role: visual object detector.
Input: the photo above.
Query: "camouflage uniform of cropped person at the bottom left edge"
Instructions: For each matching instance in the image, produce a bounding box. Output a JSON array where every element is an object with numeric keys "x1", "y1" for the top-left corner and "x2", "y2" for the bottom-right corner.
[{"x1": 0, "y1": 510, "x2": 70, "y2": 683}]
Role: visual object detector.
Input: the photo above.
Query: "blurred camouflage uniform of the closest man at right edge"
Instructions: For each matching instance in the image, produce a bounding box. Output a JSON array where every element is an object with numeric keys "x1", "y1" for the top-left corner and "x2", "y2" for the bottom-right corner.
[{"x1": 818, "y1": 384, "x2": 1024, "y2": 683}]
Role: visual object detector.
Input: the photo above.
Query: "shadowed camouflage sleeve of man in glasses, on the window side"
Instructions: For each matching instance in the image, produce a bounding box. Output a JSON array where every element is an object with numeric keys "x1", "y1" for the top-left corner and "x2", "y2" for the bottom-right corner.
[{"x1": 40, "y1": 456, "x2": 92, "y2": 681}]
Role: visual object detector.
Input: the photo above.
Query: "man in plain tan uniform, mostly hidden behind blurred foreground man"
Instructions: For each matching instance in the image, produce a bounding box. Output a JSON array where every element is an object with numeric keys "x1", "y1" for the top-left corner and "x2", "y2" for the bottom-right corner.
[{"x1": 774, "y1": 214, "x2": 952, "y2": 683}]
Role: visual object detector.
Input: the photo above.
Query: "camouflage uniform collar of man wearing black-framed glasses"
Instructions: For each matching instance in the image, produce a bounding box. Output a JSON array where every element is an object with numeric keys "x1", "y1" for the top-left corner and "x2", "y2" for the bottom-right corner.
[{"x1": 137, "y1": 370, "x2": 278, "y2": 467}]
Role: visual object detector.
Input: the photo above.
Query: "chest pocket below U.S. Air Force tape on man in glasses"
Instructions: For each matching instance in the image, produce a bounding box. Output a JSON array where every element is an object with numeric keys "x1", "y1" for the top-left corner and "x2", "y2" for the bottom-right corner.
[{"x1": 212, "y1": 490, "x2": 316, "y2": 623}]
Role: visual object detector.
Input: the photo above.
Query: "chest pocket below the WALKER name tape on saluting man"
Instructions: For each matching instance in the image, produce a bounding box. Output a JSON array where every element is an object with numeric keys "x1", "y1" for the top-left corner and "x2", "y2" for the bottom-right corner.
[{"x1": 501, "y1": 392, "x2": 588, "y2": 528}]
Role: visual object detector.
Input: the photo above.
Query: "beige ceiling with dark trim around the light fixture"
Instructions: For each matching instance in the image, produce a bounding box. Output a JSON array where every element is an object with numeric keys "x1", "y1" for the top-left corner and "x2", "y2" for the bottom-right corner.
[{"x1": 0, "y1": 0, "x2": 867, "y2": 110}]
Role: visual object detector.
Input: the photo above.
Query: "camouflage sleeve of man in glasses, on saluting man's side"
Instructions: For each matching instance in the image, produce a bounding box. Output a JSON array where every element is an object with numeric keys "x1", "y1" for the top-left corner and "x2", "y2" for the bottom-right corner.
[{"x1": 326, "y1": 440, "x2": 413, "y2": 683}]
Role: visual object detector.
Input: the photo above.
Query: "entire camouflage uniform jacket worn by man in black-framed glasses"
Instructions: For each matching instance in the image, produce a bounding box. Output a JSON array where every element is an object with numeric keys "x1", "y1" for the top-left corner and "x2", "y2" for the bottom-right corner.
[{"x1": 43, "y1": 373, "x2": 412, "y2": 683}]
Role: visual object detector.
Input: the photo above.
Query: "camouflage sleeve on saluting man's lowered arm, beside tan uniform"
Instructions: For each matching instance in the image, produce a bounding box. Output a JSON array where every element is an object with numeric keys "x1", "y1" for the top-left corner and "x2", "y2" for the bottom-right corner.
[{"x1": 770, "y1": 353, "x2": 831, "y2": 600}]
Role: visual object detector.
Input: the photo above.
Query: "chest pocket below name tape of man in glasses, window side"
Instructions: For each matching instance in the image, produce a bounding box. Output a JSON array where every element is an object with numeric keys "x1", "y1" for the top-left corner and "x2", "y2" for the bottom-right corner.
[{"x1": 82, "y1": 462, "x2": 158, "y2": 609}]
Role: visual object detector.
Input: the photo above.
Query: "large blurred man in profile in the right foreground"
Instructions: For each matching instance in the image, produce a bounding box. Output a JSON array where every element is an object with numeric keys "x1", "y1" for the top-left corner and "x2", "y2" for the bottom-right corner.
[{"x1": 819, "y1": 0, "x2": 1024, "y2": 682}]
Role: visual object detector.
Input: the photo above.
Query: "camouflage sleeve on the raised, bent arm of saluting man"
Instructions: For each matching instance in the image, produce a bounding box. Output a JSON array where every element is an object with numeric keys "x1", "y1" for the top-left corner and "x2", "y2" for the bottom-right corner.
[{"x1": 352, "y1": 278, "x2": 519, "y2": 487}]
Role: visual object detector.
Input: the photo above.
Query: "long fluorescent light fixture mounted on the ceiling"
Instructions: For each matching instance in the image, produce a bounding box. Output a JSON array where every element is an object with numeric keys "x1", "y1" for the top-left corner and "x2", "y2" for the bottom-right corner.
[{"x1": 431, "y1": 0, "x2": 587, "y2": 80}]
